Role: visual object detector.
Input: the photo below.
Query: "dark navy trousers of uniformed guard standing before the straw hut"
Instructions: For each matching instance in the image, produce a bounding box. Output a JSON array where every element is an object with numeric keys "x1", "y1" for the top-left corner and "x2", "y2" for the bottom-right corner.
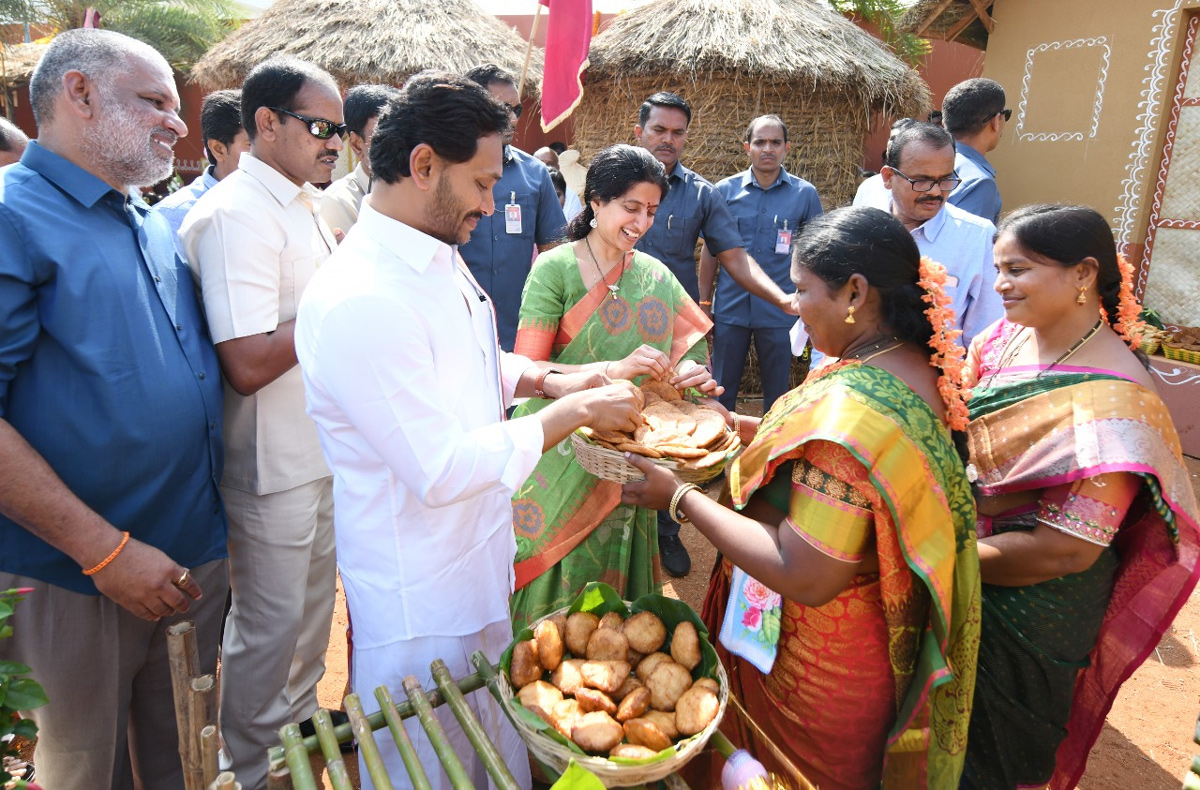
[{"x1": 715, "y1": 322, "x2": 792, "y2": 413}]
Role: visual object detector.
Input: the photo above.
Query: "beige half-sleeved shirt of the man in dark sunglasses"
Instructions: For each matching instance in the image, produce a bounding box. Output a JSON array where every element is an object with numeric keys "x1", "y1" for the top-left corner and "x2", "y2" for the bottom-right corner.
[{"x1": 179, "y1": 154, "x2": 336, "y2": 495}]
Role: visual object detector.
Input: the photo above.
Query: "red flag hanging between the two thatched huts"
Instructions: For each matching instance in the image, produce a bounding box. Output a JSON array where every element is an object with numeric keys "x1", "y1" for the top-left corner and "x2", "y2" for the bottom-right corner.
[{"x1": 539, "y1": 0, "x2": 592, "y2": 132}]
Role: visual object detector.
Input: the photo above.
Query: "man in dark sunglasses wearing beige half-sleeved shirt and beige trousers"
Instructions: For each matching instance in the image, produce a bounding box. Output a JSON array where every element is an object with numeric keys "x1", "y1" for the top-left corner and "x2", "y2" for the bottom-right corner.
[{"x1": 180, "y1": 56, "x2": 346, "y2": 790}]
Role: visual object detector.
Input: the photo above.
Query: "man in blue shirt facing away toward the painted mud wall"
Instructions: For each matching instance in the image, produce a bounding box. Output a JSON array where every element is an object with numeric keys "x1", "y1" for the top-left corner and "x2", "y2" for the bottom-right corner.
[{"x1": 942, "y1": 78, "x2": 1013, "y2": 223}]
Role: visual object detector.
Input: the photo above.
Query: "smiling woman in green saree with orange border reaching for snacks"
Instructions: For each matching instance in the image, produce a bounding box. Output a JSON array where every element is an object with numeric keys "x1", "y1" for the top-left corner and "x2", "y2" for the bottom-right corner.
[{"x1": 510, "y1": 145, "x2": 724, "y2": 629}]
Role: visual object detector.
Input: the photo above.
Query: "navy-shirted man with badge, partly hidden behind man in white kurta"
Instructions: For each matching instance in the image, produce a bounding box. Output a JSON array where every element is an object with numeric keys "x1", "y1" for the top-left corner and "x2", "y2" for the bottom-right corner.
[{"x1": 458, "y1": 64, "x2": 566, "y2": 351}]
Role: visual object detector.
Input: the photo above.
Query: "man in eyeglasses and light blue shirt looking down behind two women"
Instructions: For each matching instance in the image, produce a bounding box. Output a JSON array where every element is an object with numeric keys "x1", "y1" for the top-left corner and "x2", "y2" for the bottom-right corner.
[{"x1": 882, "y1": 124, "x2": 1004, "y2": 346}]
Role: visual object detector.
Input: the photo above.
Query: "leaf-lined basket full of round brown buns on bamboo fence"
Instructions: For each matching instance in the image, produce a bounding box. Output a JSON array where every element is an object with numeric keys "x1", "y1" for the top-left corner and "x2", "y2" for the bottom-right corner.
[{"x1": 499, "y1": 582, "x2": 730, "y2": 788}]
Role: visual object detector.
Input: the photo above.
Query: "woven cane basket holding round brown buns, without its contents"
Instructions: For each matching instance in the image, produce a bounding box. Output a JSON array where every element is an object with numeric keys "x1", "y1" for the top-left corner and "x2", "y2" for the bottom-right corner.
[{"x1": 498, "y1": 602, "x2": 730, "y2": 788}]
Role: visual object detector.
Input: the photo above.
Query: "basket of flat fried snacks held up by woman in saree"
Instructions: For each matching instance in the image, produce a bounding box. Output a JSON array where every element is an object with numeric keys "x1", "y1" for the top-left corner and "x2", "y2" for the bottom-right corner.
[{"x1": 571, "y1": 381, "x2": 742, "y2": 484}]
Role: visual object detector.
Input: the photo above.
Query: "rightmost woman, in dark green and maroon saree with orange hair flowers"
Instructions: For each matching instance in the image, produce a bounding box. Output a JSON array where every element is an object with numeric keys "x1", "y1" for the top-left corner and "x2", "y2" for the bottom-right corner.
[{"x1": 961, "y1": 205, "x2": 1200, "y2": 790}]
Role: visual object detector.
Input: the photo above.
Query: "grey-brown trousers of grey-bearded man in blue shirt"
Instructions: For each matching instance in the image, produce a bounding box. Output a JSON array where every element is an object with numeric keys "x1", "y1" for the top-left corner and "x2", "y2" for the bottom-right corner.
[{"x1": 0, "y1": 559, "x2": 229, "y2": 790}]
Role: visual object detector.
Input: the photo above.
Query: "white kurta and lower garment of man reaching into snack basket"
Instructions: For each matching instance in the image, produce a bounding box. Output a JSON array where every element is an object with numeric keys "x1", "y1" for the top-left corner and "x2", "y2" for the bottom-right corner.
[{"x1": 296, "y1": 205, "x2": 544, "y2": 788}]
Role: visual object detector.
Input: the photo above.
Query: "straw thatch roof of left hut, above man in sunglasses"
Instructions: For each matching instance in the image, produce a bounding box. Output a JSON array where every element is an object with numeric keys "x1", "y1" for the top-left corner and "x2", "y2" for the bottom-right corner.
[{"x1": 191, "y1": 0, "x2": 542, "y2": 95}]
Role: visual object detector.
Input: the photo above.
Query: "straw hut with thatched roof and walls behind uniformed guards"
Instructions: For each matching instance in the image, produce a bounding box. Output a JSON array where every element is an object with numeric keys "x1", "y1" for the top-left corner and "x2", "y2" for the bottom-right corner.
[{"x1": 575, "y1": 0, "x2": 930, "y2": 208}]
